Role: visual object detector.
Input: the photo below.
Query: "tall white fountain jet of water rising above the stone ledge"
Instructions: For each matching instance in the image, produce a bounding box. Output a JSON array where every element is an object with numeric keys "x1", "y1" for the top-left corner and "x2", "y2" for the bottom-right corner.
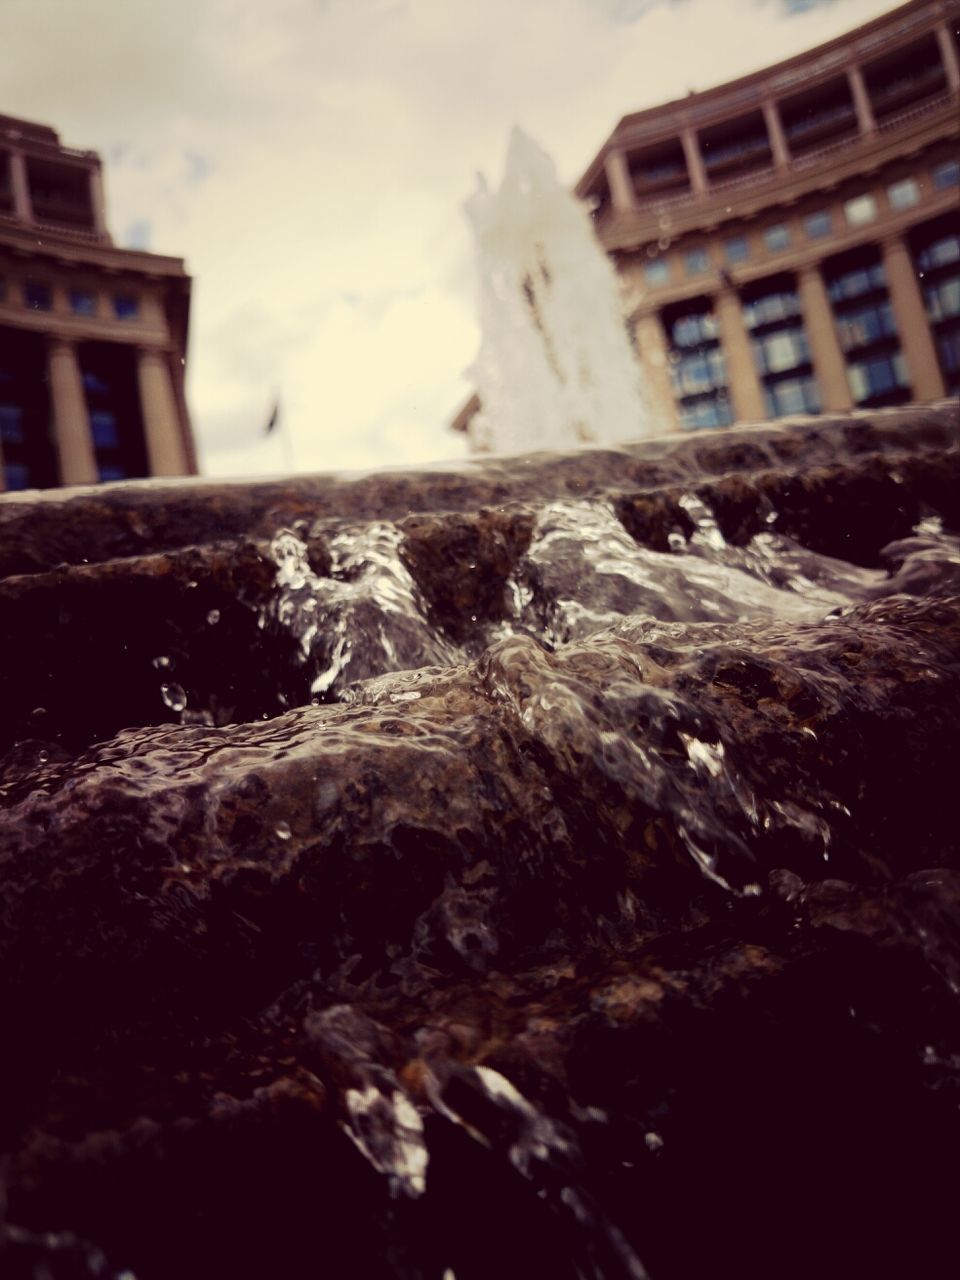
[{"x1": 465, "y1": 128, "x2": 657, "y2": 452}]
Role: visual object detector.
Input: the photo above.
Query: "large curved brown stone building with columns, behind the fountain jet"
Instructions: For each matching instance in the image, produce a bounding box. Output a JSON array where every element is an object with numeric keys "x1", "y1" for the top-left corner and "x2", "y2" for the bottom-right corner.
[{"x1": 453, "y1": 0, "x2": 960, "y2": 445}]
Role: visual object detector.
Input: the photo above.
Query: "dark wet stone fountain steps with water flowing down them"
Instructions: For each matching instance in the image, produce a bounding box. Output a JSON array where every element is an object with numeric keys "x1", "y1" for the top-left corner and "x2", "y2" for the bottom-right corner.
[{"x1": 0, "y1": 408, "x2": 960, "y2": 1280}]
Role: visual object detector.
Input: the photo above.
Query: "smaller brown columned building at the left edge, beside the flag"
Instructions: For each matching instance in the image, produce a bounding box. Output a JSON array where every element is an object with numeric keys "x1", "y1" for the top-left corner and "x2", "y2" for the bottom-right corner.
[{"x1": 0, "y1": 115, "x2": 197, "y2": 489}]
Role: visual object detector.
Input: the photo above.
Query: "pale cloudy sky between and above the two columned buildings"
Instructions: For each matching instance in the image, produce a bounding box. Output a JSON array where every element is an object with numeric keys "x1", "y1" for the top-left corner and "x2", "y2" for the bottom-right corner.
[{"x1": 0, "y1": 0, "x2": 892, "y2": 475}]
